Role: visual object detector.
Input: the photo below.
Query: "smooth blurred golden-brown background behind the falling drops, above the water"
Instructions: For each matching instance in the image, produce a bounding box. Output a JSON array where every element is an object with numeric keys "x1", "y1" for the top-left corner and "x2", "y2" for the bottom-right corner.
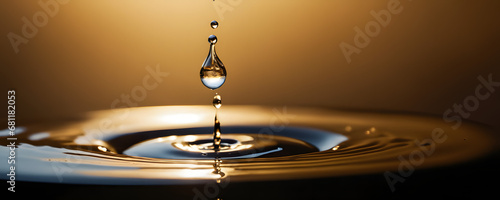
[{"x1": 0, "y1": 0, "x2": 500, "y2": 128}]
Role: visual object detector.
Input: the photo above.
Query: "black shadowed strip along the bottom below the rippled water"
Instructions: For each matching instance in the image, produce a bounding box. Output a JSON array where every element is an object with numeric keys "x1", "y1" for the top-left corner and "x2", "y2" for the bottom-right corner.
[{"x1": 7, "y1": 152, "x2": 500, "y2": 200}]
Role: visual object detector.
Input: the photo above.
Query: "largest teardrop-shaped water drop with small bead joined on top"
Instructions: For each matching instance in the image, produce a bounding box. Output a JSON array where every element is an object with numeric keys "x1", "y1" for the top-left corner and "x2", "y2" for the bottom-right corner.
[{"x1": 200, "y1": 35, "x2": 226, "y2": 90}]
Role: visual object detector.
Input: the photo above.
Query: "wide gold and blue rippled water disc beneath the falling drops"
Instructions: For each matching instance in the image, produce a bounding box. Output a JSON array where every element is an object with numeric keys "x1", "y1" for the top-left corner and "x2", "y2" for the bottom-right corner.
[{"x1": 0, "y1": 106, "x2": 496, "y2": 185}]
